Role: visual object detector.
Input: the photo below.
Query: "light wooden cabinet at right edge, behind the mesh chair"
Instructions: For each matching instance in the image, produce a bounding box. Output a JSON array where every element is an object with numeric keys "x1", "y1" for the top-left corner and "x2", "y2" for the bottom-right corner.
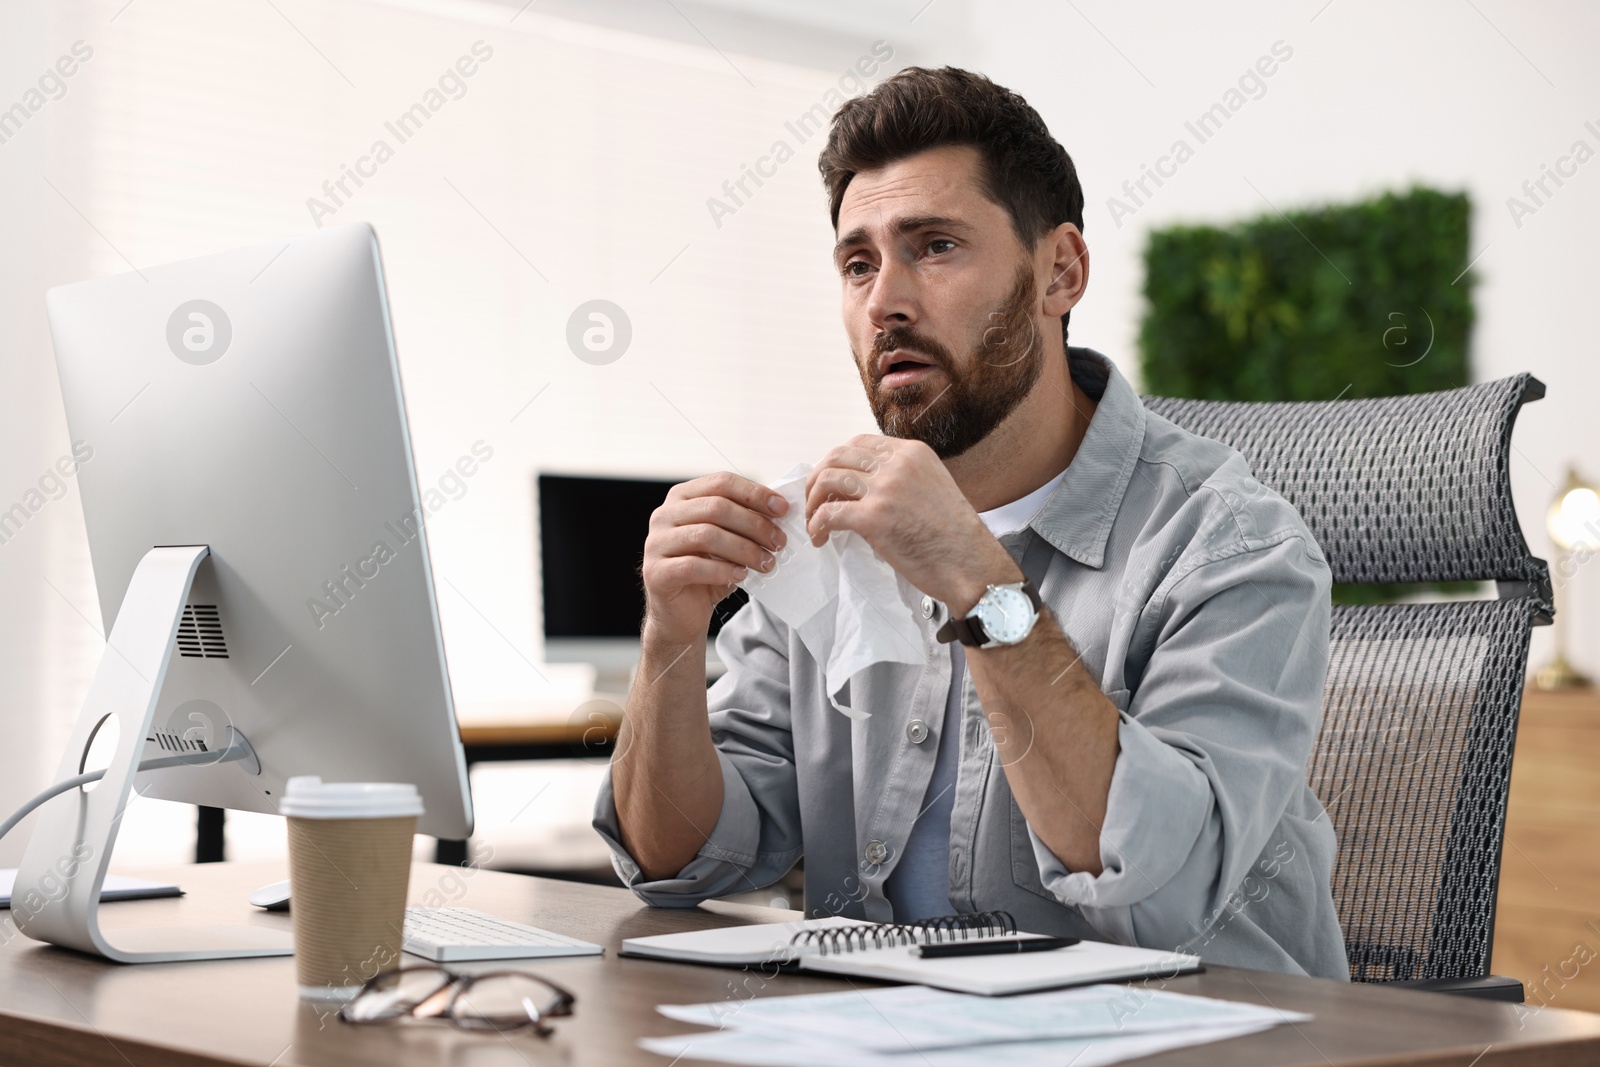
[{"x1": 1493, "y1": 689, "x2": 1600, "y2": 1011}]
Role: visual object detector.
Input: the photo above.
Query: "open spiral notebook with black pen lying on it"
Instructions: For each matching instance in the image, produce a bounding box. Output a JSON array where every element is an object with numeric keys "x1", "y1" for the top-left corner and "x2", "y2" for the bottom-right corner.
[{"x1": 621, "y1": 912, "x2": 1200, "y2": 997}]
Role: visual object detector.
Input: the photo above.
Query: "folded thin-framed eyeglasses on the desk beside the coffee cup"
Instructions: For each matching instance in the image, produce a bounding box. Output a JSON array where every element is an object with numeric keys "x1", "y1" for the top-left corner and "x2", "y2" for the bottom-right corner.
[{"x1": 339, "y1": 966, "x2": 578, "y2": 1037}]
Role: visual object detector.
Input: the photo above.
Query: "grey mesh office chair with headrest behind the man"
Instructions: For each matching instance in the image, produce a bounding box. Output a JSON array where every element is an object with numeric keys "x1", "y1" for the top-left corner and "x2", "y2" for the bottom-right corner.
[{"x1": 1144, "y1": 374, "x2": 1554, "y2": 1001}]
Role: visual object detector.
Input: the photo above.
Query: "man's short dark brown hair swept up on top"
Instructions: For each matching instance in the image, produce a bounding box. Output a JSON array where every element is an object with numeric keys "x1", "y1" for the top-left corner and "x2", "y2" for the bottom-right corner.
[{"x1": 816, "y1": 67, "x2": 1083, "y2": 341}]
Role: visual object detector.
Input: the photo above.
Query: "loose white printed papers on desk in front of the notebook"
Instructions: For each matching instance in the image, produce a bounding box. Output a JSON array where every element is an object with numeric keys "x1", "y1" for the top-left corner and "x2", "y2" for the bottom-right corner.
[{"x1": 640, "y1": 985, "x2": 1310, "y2": 1067}]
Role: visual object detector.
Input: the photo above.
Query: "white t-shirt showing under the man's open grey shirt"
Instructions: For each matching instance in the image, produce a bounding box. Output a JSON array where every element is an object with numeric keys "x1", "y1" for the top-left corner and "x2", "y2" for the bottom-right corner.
[{"x1": 883, "y1": 470, "x2": 1067, "y2": 921}]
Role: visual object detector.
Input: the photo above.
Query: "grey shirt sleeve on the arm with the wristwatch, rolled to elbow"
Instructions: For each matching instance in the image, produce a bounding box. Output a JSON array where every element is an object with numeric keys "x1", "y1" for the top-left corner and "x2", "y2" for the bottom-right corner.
[{"x1": 1029, "y1": 536, "x2": 1331, "y2": 945}]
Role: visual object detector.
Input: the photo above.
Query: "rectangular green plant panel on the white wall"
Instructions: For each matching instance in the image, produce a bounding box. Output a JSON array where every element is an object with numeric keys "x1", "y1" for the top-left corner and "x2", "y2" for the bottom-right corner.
[{"x1": 1139, "y1": 187, "x2": 1474, "y2": 603}]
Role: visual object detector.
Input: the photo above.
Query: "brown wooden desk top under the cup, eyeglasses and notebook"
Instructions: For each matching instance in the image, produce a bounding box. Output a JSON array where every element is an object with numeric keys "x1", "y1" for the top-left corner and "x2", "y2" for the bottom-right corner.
[{"x1": 0, "y1": 864, "x2": 1600, "y2": 1067}]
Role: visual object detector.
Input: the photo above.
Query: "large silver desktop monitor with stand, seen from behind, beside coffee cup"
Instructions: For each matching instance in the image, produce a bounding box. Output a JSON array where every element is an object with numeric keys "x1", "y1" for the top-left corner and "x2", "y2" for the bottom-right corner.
[{"x1": 16, "y1": 224, "x2": 472, "y2": 960}]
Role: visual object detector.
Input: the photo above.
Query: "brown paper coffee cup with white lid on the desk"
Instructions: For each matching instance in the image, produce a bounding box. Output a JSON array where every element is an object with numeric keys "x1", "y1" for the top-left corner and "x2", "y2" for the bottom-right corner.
[{"x1": 280, "y1": 777, "x2": 422, "y2": 1000}]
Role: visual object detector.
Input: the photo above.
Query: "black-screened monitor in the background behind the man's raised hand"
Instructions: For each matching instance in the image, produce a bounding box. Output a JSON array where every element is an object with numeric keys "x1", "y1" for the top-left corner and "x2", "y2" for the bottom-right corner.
[{"x1": 538, "y1": 474, "x2": 749, "y2": 675}]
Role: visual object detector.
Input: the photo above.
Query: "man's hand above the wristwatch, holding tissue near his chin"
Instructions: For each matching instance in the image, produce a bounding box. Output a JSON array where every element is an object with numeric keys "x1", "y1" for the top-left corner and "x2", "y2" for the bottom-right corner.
[{"x1": 805, "y1": 434, "x2": 1022, "y2": 617}]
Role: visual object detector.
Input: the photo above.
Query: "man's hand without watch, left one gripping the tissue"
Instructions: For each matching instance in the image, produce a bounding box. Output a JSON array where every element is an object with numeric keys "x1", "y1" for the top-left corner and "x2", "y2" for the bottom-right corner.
[{"x1": 642, "y1": 472, "x2": 789, "y2": 643}]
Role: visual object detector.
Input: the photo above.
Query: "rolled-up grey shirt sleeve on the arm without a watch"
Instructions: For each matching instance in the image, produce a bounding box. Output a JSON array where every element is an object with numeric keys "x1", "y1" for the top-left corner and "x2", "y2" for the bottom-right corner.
[{"x1": 594, "y1": 603, "x2": 802, "y2": 907}]
